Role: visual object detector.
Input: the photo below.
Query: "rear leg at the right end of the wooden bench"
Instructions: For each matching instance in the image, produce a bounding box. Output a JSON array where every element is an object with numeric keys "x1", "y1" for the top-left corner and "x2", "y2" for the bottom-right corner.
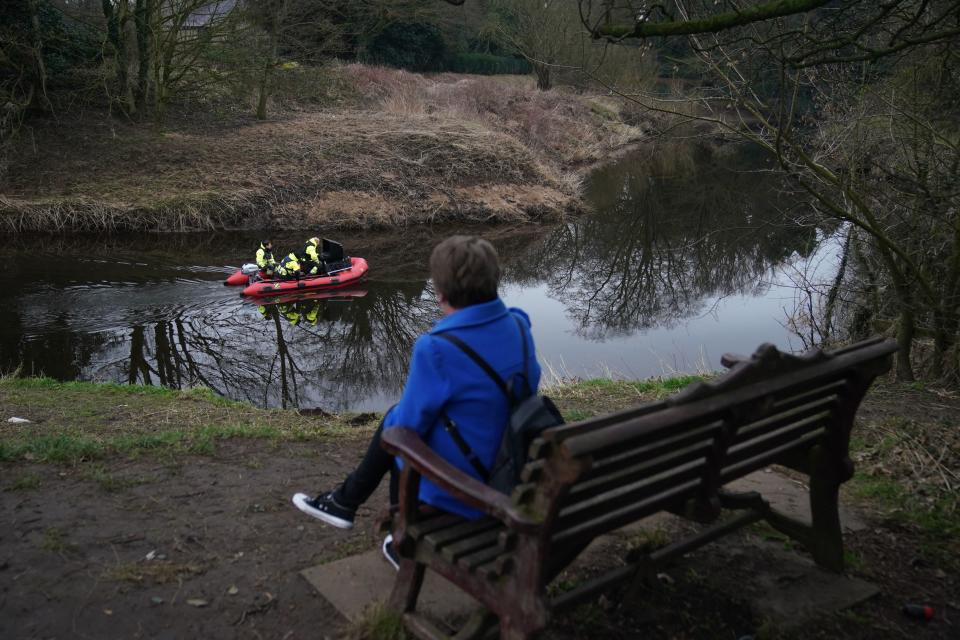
[{"x1": 810, "y1": 447, "x2": 843, "y2": 573}]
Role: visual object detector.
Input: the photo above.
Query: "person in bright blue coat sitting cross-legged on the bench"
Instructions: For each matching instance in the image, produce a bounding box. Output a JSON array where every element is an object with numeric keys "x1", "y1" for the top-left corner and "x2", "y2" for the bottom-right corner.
[{"x1": 293, "y1": 236, "x2": 540, "y2": 567}]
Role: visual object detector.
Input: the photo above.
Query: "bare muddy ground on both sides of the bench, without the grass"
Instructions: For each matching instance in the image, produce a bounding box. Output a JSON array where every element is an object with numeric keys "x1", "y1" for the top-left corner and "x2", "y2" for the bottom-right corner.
[{"x1": 0, "y1": 382, "x2": 960, "y2": 640}]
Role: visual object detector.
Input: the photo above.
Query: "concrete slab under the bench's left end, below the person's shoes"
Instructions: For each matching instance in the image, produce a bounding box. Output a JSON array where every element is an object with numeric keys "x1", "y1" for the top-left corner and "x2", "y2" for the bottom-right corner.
[{"x1": 300, "y1": 550, "x2": 479, "y2": 623}]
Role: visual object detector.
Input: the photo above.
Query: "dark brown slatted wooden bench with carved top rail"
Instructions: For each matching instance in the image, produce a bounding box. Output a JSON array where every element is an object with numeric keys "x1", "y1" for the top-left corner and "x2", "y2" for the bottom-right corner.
[{"x1": 383, "y1": 339, "x2": 896, "y2": 639}]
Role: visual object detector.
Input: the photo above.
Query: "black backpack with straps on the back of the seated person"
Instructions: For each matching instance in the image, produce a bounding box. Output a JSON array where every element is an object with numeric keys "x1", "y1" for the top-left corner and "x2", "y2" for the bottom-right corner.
[{"x1": 435, "y1": 314, "x2": 563, "y2": 495}]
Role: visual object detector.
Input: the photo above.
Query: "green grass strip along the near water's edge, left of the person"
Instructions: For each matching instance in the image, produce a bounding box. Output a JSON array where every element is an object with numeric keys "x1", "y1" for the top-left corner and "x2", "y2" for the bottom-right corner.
[{"x1": 0, "y1": 376, "x2": 378, "y2": 464}]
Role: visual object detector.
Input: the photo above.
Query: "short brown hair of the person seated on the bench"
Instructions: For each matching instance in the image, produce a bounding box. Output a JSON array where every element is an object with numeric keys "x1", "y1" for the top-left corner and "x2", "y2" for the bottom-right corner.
[{"x1": 430, "y1": 236, "x2": 500, "y2": 309}]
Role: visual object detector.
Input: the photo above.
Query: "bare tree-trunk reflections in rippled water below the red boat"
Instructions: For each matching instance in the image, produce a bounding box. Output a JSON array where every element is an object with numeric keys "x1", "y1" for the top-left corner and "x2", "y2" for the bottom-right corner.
[{"x1": 114, "y1": 281, "x2": 437, "y2": 409}]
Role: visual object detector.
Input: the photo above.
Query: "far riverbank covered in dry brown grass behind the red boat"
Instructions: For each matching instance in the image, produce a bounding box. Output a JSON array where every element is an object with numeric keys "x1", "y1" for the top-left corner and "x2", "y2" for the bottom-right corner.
[{"x1": 0, "y1": 64, "x2": 649, "y2": 233}]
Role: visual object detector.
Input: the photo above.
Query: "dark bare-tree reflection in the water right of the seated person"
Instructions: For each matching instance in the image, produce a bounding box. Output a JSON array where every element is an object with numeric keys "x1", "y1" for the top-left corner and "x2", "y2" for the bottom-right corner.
[{"x1": 514, "y1": 142, "x2": 817, "y2": 340}]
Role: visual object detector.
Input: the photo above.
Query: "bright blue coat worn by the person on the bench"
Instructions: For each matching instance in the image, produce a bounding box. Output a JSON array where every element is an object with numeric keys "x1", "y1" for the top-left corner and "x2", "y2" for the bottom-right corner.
[{"x1": 383, "y1": 298, "x2": 540, "y2": 518}]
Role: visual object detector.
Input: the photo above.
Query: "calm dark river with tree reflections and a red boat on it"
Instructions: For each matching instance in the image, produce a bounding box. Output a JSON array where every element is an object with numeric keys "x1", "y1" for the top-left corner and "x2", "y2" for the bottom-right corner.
[{"x1": 0, "y1": 144, "x2": 823, "y2": 411}]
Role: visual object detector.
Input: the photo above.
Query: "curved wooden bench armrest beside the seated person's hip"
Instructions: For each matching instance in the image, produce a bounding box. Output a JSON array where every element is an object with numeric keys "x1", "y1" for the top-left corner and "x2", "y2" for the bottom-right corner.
[{"x1": 380, "y1": 427, "x2": 540, "y2": 533}]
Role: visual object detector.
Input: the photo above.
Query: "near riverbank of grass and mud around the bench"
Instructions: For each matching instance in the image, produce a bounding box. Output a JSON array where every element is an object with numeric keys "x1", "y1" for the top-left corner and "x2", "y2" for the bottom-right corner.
[{"x1": 0, "y1": 377, "x2": 960, "y2": 639}]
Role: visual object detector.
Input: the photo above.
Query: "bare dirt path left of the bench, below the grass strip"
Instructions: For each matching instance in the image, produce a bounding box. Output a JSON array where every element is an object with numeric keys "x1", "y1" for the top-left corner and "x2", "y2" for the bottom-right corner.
[{"x1": 0, "y1": 440, "x2": 383, "y2": 639}]
